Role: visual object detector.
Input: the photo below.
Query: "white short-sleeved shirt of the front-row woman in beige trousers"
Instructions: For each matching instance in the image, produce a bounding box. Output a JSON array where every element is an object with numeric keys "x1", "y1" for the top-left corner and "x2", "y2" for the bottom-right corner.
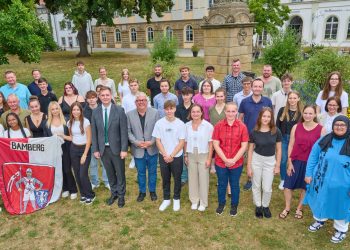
[{"x1": 186, "y1": 120, "x2": 214, "y2": 154}]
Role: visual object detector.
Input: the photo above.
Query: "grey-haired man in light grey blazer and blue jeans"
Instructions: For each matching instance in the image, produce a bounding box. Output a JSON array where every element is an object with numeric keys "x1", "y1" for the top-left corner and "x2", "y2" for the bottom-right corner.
[{"x1": 126, "y1": 92, "x2": 159, "y2": 202}]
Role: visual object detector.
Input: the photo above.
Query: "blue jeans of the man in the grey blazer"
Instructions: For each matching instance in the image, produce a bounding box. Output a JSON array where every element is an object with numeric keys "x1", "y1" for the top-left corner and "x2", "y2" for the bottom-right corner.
[{"x1": 134, "y1": 150, "x2": 158, "y2": 193}]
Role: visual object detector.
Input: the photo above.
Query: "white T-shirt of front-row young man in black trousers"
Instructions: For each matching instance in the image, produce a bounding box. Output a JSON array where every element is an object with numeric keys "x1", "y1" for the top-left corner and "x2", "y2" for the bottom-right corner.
[{"x1": 152, "y1": 117, "x2": 186, "y2": 157}]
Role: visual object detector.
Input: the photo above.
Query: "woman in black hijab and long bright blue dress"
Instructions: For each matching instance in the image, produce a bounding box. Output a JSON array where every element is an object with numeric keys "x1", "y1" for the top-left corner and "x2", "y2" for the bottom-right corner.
[{"x1": 304, "y1": 116, "x2": 350, "y2": 243}]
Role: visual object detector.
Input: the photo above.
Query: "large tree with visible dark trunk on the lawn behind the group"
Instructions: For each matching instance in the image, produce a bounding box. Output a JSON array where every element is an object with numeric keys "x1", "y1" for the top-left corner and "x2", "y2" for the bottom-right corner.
[{"x1": 45, "y1": 0, "x2": 173, "y2": 57}]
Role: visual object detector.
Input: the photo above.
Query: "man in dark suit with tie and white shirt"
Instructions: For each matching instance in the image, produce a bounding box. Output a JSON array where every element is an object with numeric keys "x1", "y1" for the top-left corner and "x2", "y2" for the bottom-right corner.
[{"x1": 91, "y1": 86, "x2": 128, "y2": 207}]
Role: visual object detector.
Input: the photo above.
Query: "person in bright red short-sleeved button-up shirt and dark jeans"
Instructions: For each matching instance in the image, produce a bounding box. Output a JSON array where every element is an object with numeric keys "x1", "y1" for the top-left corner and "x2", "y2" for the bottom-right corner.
[{"x1": 213, "y1": 102, "x2": 249, "y2": 216}]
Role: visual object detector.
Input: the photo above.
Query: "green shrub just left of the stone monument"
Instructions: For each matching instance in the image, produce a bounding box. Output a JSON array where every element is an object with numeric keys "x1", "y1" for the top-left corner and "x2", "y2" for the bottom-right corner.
[{"x1": 150, "y1": 36, "x2": 177, "y2": 63}]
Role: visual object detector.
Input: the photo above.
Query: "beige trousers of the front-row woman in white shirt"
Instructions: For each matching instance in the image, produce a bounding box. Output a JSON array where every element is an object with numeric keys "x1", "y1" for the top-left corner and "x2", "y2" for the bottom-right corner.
[{"x1": 187, "y1": 149, "x2": 209, "y2": 207}]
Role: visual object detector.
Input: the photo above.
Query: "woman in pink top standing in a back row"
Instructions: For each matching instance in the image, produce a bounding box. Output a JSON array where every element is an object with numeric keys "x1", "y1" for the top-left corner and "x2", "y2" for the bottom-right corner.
[{"x1": 192, "y1": 80, "x2": 216, "y2": 122}]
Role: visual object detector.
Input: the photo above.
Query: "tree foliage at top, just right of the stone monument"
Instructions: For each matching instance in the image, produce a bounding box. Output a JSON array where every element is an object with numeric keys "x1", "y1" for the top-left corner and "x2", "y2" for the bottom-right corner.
[{"x1": 248, "y1": 0, "x2": 290, "y2": 35}]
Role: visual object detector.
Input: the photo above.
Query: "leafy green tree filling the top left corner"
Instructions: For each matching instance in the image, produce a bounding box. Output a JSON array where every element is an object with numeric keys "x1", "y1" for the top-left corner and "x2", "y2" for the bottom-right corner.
[{"x1": 0, "y1": 0, "x2": 53, "y2": 65}]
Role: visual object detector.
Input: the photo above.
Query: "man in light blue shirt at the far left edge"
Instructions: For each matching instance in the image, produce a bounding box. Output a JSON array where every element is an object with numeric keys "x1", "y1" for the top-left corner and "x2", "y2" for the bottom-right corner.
[{"x1": 0, "y1": 70, "x2": 31, "y2": 109}]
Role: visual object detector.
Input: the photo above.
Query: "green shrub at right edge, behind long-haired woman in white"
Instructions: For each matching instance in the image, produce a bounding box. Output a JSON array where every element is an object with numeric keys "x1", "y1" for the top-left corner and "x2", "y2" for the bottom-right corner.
[{"x1": 305, "y1": 48, "x2": 350, "y2": 89}]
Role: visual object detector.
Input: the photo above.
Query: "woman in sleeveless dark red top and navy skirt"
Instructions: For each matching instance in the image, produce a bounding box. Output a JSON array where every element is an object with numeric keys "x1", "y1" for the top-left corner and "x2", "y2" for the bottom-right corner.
[{"x1": 279, "y1": 105, "x2": 326, "y2": 219}]
